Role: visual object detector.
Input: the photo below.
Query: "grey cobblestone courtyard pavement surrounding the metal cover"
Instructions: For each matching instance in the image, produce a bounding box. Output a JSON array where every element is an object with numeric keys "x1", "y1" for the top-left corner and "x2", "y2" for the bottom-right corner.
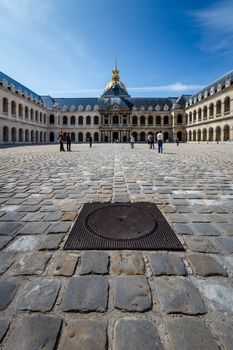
[{"x1": 0, "y1": 144, "x2": 233, "y2": 350}]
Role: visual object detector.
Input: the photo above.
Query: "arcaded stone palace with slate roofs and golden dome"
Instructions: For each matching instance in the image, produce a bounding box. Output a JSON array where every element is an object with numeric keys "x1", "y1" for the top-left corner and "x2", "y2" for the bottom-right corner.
[{"x1": 0, "y1": 66, "x2": 233, "y2": 144}]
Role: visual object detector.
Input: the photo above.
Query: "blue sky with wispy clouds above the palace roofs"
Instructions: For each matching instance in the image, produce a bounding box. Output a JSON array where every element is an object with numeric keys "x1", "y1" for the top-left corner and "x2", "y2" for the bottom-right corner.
[{"x1": 0, "y1": 0, "x2": 233, "y2": 97}]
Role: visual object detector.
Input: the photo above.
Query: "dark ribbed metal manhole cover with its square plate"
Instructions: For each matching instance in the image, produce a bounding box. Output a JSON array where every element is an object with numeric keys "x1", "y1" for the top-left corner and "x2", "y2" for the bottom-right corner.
[{"x1": 64, "y1": 202, "x2": 184, "y2": 250}]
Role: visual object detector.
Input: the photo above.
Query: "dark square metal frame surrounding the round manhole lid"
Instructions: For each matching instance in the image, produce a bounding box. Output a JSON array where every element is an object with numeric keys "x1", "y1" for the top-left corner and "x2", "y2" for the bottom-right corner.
[{"x1": 63, "y1": 202, "x2": 185, "y2": 251}]
